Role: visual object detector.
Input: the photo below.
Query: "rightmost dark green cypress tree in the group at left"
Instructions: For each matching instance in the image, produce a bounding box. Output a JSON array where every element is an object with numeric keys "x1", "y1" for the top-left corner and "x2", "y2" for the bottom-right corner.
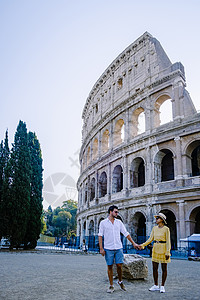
[{"x1": 25, "y1": 132, "x2": 43, "y2": 249}]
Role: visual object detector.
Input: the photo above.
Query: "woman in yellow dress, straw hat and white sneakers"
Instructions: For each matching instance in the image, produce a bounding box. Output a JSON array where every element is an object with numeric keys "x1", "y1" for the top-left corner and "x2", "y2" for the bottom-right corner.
[{"x1": 139, "y1": 213, "x2": 171, "y2": 293}]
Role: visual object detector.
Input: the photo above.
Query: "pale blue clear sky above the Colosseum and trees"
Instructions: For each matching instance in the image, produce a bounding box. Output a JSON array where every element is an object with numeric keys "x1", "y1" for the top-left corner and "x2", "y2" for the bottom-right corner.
[{"x1": 0, "y1": 0, "x2": 200, "y2": 207}]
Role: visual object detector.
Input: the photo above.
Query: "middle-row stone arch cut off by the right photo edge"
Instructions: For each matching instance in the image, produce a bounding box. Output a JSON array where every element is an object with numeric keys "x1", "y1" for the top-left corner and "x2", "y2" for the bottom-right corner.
[{"x1": 186, "y1": 140, "x2": 200, "y2": 176}]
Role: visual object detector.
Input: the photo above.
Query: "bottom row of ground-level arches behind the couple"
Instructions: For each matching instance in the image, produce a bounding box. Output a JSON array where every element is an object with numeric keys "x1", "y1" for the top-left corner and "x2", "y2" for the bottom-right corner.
[{"x1": 79, "y1": 206, "x2": 200, "y2": 250}]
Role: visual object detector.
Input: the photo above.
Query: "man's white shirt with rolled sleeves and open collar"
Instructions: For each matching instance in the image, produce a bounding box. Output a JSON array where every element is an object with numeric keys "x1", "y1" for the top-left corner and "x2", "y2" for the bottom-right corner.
[{"x1": 98, "y1": 218, "x2": 129, "y2": 250}]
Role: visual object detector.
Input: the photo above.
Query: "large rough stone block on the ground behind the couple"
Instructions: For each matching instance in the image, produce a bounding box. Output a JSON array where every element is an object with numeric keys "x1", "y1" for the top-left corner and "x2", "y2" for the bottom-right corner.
[{"x1": 113, "y1": 254, "x2": 148, "y2": 279}]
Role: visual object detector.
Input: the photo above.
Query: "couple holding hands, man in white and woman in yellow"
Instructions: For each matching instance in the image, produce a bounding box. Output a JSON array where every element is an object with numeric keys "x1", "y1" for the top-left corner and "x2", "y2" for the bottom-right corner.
[{"x1": 98, "y1": 205, "x2": 171, "y2": 293}]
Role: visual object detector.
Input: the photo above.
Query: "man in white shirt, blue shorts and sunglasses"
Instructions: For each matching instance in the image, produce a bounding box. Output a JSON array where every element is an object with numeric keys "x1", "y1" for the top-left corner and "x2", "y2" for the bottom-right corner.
[{"x1": 98, "y1": 205, "x2": 138, "y2": 293}]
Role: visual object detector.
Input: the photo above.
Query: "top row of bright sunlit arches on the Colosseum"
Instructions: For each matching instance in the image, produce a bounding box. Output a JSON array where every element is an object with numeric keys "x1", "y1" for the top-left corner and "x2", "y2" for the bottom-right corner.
[{"x1": 82, "y1": 95, "x2": 173, "y2": 169}]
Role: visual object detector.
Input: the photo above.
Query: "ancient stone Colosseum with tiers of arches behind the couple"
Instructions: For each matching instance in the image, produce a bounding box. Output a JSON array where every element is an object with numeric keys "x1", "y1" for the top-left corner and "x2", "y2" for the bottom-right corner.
[{"x1": 77, "y1": 32, "x2": 200, "y2": 249}]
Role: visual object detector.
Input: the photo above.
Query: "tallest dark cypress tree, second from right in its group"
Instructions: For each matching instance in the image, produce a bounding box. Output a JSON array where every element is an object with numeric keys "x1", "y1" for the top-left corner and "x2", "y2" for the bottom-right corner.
[{"x1": 8, "y1": 121, "x2": 31, "y2": 249}]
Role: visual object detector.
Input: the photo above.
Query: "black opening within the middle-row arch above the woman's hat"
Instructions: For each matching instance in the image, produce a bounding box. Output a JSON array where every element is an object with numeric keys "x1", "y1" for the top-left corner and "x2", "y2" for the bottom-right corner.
[{"x1": 161, "y1": 150, "x2": 174, "y2": 181}]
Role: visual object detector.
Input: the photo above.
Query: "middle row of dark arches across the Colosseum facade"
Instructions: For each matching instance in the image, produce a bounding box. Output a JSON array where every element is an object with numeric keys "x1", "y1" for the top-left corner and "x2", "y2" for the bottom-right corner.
[{"x1": 80, "y1": 141, "x2": 200, "y2": 203}]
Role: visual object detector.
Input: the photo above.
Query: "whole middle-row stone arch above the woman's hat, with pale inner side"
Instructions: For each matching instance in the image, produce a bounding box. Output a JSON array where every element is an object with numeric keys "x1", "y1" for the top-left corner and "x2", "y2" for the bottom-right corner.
[{"x1": 154, "y1": 149, "x2": 174, "y2": 183}]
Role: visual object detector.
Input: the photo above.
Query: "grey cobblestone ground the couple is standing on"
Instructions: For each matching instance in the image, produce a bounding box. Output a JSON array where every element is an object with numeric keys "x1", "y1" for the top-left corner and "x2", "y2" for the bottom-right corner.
[{"x1": 0, "y1": 251, "x2": 200, "y2": 300}]
